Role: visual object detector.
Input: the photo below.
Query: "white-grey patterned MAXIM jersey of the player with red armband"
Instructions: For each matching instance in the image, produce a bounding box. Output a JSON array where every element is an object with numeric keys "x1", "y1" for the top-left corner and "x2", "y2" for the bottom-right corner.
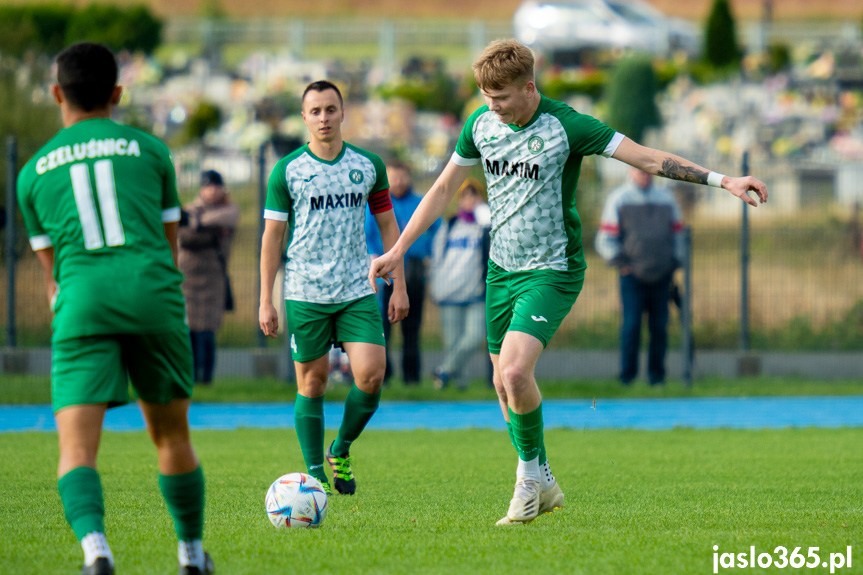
[{"x1": 264, "y1": 142, "x2": 389, "y2": 303}]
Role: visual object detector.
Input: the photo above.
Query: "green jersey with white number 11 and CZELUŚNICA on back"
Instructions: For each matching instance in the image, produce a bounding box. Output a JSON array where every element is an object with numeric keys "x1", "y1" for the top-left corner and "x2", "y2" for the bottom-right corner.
[{"x1": 18, "y1": 119, "x2": 185, "y2": 341}]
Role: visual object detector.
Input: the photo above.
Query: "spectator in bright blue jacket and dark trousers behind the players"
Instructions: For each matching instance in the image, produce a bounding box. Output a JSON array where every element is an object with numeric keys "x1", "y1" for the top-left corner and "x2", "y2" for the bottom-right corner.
[{"x1": 366, "y1": 161, "x2": 440, "y2": 385}]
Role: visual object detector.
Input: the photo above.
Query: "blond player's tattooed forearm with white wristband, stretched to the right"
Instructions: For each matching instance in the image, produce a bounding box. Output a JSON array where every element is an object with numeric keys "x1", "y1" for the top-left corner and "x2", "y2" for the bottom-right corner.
[{"x1": 612, "y1": 138, "x2": 767, "y2": 207}]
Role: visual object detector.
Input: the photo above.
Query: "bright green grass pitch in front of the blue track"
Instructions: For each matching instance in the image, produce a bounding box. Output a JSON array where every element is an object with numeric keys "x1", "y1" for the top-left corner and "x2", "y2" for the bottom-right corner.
[{"x1": 0, "y1": 429, "x2": 863, "y2": 575}]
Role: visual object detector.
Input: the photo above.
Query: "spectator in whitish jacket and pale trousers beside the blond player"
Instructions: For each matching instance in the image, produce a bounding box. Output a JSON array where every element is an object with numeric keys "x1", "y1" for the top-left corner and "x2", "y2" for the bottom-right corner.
[{"x1": 431, "y1": 178, "x2": 491, "y2": 389}]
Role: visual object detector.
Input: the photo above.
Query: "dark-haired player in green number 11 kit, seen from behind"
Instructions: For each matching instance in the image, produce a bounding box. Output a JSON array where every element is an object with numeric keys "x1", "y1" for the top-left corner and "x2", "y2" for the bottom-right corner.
[{"x1": 18, "y1": 42, "x2": 213, "y2": 575}]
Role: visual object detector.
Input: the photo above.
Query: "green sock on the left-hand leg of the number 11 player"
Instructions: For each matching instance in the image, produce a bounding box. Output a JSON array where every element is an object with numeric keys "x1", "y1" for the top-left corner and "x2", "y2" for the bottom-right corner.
[{"x1": 57, "y1": 467, "x2": 105, "y2": 541}]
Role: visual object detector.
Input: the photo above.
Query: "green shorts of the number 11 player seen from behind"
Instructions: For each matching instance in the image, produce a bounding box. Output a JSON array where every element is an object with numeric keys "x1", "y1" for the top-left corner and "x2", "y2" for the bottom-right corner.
[{"x1": 51, "y1": 326, "x2": 194, "y2": 412}]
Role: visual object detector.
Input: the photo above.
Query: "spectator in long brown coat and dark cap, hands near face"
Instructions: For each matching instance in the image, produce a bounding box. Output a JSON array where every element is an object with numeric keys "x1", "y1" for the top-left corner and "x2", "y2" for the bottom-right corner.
[{"x1": 178, "y1": 170, "x2": 240, "y2": 384}]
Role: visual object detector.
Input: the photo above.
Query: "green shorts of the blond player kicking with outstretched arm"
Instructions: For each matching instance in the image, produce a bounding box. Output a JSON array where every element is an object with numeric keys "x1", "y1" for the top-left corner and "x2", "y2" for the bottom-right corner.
[{"x1": 485, "y1": 260, "x2": 584, "y2": 354}]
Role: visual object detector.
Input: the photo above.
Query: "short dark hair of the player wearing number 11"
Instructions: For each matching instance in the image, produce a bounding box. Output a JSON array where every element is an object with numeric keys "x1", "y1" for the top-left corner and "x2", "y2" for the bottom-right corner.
[{"x1": 57, "y1": 42, "x2": 117, "y2": 112}]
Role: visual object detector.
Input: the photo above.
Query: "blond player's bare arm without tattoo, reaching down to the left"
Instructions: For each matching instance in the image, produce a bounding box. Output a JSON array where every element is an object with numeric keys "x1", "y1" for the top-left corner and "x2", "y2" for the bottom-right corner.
[{"x1": 369, "y1": 162, "x2": 471, "y2": 286}]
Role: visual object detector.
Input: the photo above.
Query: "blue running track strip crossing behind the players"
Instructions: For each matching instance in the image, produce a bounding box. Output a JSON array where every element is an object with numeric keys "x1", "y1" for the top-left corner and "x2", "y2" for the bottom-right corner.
[{"x1": 0, "y1": 396, "x2": 863, "y2": 432}]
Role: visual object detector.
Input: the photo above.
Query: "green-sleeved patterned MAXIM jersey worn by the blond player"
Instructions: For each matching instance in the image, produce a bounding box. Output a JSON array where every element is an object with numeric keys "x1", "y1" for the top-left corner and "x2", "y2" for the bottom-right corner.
[{"x1": 452, "y1": 96, "x2": 623, "y2": 271}]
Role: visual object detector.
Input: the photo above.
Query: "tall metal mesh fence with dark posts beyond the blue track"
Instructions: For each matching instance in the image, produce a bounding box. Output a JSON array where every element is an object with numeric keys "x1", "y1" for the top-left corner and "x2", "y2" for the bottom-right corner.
[{"x1": 5, "y1": 141, "x2": 863, "y2": 360}]
